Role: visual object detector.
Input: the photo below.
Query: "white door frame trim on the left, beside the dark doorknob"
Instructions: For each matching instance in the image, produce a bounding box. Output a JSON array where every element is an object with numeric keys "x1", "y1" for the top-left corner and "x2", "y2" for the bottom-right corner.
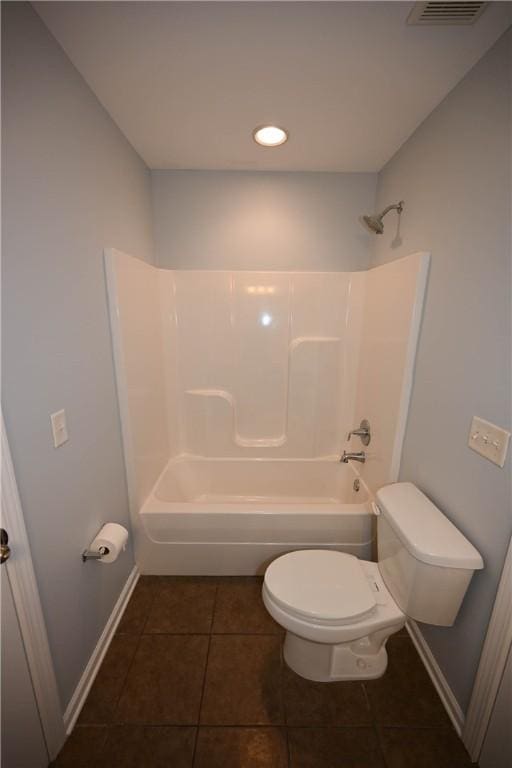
[{"x1": 1, "y1": 414, "x2": 66, "y2": 760}]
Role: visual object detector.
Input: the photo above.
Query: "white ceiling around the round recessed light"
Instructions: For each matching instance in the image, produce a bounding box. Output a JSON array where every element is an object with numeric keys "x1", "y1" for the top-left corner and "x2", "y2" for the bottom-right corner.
[{"x1": 33, "y1": 2, "x2": 512, "y2": 171}]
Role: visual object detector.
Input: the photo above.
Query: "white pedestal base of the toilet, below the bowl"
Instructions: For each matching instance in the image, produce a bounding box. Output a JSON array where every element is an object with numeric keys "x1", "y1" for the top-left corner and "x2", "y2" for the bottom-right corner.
[{"x1": 284, "y1": 629, "x2": 396, "y2": 683}]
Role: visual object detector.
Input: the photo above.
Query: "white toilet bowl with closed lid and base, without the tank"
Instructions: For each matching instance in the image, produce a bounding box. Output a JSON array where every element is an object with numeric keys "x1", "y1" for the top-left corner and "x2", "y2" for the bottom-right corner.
[{"x1": 263, "y1": 550, "x2": 406, "y2": 682}]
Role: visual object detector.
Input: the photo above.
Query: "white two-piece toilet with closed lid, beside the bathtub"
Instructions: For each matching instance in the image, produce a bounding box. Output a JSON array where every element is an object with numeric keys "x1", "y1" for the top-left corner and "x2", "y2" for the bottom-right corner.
[{"x1": 263, "y1": 483, "x2": 483, "y2": 682}]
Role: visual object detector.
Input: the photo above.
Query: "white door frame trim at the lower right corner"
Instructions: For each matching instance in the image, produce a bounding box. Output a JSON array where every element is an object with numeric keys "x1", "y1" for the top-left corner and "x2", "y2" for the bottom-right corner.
[{"x1": 463, "y1": 539, "x2": 512, "y2": 761}]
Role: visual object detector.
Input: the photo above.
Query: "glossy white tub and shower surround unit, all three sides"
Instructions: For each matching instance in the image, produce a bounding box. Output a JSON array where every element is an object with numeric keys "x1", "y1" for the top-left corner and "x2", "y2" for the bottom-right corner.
[{"x1": 105, "y1": 250, "x2": 429, "y2": 575}]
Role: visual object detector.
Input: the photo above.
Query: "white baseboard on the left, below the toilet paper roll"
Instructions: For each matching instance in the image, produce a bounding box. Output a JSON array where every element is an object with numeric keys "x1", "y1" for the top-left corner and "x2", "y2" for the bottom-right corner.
[{"x1": 64, "y1": 565, "x2": 139, "y2": 736}]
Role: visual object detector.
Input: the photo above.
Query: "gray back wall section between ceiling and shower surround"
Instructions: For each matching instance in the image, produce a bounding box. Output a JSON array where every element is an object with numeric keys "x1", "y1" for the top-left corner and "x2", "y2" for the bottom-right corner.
[{"x1": 151, "y1": 171, "x2": 377, "y2": 271}]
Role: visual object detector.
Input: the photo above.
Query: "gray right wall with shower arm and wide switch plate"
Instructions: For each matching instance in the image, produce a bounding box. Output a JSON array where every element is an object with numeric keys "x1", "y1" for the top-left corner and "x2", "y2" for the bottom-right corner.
[{"x1": 375, "y1": 32, "x2": 512, "y2": 709}]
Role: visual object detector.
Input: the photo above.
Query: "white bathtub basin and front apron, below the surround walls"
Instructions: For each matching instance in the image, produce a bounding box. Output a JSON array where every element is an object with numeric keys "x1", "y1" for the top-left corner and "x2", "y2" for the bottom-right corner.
[{"x1": 136, "y1": 456, "x2": 373, "y2": 575}]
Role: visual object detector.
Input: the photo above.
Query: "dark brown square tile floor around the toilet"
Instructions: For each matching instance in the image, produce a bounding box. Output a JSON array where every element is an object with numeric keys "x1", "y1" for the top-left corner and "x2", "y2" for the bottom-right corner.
[{"x1": 54, "y1": 576, "x2": 471, "y2": 768}]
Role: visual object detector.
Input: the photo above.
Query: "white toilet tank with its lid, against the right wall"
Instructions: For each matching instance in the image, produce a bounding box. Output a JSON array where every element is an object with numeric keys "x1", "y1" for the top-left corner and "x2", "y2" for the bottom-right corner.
[{"x1": 377, "y1": 483, "x2": 484, "y2": 626}]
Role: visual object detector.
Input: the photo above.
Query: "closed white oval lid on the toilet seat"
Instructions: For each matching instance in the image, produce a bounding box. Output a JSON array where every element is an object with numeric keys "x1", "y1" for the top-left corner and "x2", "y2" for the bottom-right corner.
[{"x1": 265, "y1": 549, "x2": 376, "y2": 623}]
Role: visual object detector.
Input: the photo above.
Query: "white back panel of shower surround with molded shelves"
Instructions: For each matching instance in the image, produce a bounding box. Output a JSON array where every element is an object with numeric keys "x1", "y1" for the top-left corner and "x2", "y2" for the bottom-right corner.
[{"x1": 159, "y1": 270, "x2": 365, "y2": 458}]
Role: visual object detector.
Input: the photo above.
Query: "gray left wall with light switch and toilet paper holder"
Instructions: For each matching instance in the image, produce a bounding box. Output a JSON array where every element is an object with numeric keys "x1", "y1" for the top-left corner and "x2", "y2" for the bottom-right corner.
[{"x1": 2, "y1": 3, "x2": 152, "y2": 706}]
